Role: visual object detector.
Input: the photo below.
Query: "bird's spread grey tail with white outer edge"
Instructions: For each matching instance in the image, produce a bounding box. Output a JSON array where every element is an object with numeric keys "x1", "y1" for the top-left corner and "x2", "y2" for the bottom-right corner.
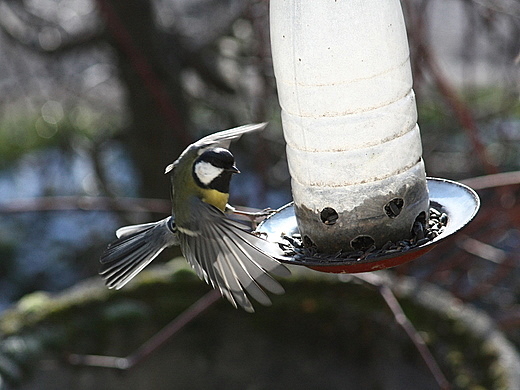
[{"x1": 99, "y1": 217, "x2": 179, "y2": 289}]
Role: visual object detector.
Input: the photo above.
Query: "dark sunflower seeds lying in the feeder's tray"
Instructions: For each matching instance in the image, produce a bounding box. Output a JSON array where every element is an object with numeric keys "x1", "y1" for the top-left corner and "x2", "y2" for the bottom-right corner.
[{"x1": 279, "y1": 207, "x2": 448, "y2": 263}]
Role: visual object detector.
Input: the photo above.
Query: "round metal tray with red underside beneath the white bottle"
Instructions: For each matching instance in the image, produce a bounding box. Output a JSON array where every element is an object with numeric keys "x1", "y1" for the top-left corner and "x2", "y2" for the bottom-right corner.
[{"x1": 256, "y1": 178, "x2": 480, "y2": 273}]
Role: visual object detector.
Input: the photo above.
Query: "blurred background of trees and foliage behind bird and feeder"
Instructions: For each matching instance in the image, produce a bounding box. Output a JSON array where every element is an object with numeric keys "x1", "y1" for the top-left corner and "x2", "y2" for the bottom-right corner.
[{"x1": 0, "y1": 0, "x2": 520, "y2": 374}]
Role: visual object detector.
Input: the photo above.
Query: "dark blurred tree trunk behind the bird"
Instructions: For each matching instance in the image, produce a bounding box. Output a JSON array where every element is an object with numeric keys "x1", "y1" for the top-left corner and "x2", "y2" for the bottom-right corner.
[{"x1": 97, "y1": 0, "x2": 190, "y2": 198}]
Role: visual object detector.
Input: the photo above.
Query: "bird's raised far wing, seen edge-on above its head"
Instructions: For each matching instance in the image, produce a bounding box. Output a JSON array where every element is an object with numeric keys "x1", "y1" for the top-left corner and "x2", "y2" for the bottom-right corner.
[{"x1": 164, "y1": 122, "x2": 267, "y2": 173}]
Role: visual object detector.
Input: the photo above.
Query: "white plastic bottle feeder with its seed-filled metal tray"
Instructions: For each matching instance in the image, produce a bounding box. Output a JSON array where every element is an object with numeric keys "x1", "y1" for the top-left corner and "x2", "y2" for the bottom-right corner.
[{"x1": 264, "y1": 0, "x2": 479, "y2": 272}]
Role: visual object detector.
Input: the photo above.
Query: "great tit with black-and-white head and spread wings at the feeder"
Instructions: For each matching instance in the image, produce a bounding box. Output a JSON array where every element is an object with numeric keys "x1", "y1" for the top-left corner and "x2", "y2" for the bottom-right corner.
[{"x1": 100, "y1": 123, "x2": 290, "y2": 312}]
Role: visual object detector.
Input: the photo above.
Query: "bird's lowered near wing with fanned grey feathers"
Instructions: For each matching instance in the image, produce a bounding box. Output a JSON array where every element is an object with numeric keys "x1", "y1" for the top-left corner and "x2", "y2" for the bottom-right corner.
[{"x1": 177, "y1": 197, "x2": 290, "y2": 312}]
